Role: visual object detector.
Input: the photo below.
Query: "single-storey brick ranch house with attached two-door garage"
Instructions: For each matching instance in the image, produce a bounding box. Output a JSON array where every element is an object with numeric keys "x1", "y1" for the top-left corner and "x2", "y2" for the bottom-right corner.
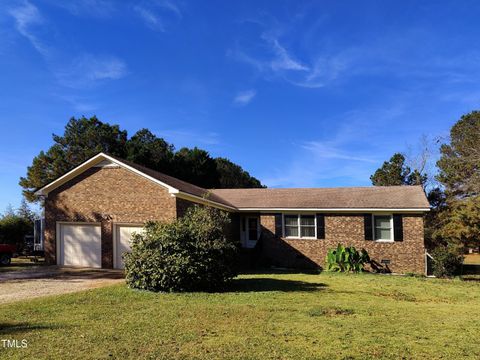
[{"x1": 36, "y1": 153, "x2": 429, "y2": 273}]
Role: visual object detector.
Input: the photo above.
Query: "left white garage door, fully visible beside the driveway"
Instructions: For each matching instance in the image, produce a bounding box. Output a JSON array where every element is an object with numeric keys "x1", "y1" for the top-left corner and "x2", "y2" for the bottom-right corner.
[{"x1": 59, "y1": 224, "x2": 102, "y2": 268}]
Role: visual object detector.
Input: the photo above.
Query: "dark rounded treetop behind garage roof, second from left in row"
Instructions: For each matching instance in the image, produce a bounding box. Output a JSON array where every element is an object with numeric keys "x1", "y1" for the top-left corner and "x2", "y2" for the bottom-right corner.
[{"x1": 126, "y1": 129, "x2": 175, "y2": 173}]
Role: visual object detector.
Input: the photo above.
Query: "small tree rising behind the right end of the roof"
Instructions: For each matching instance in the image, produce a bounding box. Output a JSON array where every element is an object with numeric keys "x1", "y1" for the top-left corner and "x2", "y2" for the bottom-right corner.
[{"x1": 370, "y1": 153, "x2": 426, "y2": 186}]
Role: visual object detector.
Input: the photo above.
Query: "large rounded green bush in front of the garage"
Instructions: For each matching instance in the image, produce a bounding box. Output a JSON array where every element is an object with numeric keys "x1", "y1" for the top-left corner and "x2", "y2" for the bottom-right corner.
[{"x1": 124, "y1": 206, "x2": 237, "y2": 291}]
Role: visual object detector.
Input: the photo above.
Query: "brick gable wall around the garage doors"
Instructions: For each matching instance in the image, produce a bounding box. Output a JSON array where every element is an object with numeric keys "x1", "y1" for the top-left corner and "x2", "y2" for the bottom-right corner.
[{"x1": 45, "y1": 167, "x2": 177, "y2": 268}]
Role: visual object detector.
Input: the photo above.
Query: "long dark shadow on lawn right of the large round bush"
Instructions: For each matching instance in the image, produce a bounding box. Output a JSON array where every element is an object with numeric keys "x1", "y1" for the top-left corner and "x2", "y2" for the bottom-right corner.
[{"x1": 226, "y1": 278, "x2": 327, "y2": 292}]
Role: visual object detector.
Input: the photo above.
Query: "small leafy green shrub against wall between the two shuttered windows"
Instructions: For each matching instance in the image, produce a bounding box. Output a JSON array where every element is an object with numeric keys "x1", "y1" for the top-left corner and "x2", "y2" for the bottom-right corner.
[{"x1": 325, "y1": 244, "x2": 370, "y2": 272}]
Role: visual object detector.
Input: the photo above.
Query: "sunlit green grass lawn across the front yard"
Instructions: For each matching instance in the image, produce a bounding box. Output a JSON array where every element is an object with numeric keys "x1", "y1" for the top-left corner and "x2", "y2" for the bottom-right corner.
[{"x1": 0, "y1": 273, "x2": 480, "y2": 359}]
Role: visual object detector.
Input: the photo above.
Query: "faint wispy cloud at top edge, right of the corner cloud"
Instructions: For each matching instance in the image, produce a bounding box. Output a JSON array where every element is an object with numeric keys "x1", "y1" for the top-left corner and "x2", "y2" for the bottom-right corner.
[{"x1": 133, "y1": 0, "x2": 183, "y2": 32}]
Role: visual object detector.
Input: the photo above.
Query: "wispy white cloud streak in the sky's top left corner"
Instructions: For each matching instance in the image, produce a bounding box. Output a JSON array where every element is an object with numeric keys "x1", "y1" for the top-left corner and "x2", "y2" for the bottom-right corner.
[{"x1": 9, "y1": 1, "x2": 49, "y2": 56}]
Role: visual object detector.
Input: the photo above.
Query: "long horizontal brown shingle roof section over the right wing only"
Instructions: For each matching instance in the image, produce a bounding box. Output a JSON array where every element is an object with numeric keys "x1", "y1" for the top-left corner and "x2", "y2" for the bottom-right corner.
[{"x1": 208, "y1": 186, "x2": 430, "y2": 209}]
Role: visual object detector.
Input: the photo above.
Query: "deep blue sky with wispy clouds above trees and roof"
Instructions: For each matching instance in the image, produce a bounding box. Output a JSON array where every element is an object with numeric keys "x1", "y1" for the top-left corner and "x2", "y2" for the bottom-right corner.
[{"x1": 0, "y1": 0, "x2": 480, "y2": 209}]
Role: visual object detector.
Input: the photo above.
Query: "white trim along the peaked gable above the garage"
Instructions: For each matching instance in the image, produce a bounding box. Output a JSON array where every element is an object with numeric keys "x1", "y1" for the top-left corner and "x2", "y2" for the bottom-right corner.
[{"x1": 35, "y1": 153, "x2": 179, "y2": 196}]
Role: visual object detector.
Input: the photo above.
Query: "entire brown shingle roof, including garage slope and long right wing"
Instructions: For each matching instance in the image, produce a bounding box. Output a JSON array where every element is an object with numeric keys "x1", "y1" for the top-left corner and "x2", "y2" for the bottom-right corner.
[{"x1": 66, "y1": 155, "x2": 430, "y2": 210}]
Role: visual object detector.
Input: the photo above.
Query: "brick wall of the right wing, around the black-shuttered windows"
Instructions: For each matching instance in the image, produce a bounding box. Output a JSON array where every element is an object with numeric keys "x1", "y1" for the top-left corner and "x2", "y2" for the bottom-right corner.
[{"x1": 260, "y1": 214, "x2": 425, "y2": 274}]
